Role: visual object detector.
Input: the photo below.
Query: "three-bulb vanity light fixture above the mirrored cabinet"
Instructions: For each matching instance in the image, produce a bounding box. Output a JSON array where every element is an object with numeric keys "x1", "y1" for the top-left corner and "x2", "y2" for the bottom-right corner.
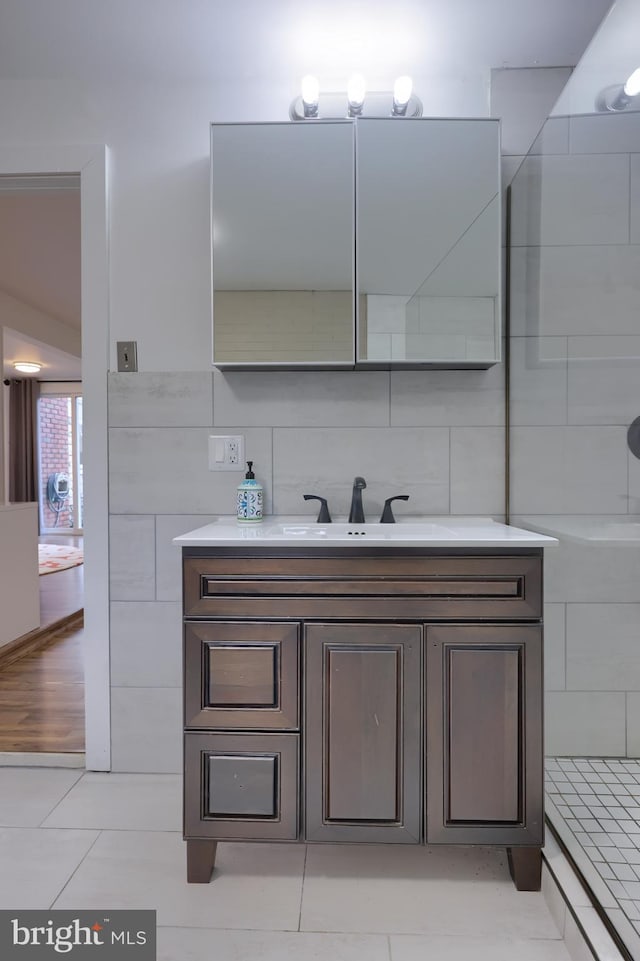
[{"x1": 289, "y1": 74, "x2": 422, "y2": 120}]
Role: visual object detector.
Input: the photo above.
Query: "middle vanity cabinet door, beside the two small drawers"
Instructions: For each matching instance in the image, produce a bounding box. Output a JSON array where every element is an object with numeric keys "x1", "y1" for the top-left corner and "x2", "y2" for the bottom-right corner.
[{"x1": 304, "y1": 623, "x2": 422, "y2": 843}]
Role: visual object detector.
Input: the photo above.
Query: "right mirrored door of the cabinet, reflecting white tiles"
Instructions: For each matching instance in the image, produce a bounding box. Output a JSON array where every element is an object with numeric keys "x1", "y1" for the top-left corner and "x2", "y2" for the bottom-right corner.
[{"x1": 356, "y1": 118, "x2": 501, "y2": 367}]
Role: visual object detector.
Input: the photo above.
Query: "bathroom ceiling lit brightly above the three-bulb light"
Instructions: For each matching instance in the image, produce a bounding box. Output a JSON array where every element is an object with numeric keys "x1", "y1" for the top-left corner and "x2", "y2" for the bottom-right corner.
[{"x1": 0, "y1": 0, "x2": 611, "y2": 89}]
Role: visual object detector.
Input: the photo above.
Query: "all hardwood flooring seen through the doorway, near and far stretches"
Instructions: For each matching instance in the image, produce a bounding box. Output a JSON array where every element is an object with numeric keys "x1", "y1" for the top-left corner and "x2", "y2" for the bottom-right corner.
[{"x1": 0, "y1": 535, "x2": 84, "y2": 754}]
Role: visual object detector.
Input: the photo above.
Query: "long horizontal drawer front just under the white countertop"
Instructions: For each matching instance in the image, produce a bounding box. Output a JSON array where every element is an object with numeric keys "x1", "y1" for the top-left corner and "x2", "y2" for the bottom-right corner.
[{"x1": 184, "y1": 553, "x2": 542, "y2": 620}]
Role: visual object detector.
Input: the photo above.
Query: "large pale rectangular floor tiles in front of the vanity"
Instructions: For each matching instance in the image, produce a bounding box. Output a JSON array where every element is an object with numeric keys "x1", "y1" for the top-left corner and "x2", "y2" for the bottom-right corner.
[{"x1": 0, "y1": 767, "x2": 569, "y2": 961}]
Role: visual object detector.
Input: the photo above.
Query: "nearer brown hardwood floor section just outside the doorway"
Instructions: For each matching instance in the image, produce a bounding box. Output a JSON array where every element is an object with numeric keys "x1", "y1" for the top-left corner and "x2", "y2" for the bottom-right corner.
[{"x1": 0, "y1": 624, "x2": 84, "y2": 753}]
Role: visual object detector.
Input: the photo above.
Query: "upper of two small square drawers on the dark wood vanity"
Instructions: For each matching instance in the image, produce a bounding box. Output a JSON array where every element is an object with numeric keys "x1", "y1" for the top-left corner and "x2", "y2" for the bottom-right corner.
[{"x1": 184, "y1": 621, "x2": 299, "y2": 729}]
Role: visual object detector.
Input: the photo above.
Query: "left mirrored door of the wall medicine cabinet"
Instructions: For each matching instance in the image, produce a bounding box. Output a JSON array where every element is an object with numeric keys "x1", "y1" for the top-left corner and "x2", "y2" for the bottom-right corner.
[{"x1": 211, "y1": 121, "x2": 354, "y2": 366}]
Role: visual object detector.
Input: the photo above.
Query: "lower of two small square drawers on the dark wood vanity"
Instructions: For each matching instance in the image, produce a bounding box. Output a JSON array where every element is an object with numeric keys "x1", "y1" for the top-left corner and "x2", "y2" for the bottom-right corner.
[{"x1": 185, "y1": 734, "x2": 299, "y2": 840}]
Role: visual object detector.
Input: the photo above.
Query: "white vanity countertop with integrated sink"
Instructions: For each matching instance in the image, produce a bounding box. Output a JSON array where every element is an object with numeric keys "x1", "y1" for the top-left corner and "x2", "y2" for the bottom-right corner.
[{"x1": 173, "y1": 515, "x2": 558, "y2": 548}]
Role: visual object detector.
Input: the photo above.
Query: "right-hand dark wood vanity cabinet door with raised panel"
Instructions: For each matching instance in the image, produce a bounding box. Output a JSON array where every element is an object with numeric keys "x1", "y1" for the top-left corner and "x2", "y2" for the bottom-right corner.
[{"x1": 426, "y1": 624, "x2": 543, "y2": 845}]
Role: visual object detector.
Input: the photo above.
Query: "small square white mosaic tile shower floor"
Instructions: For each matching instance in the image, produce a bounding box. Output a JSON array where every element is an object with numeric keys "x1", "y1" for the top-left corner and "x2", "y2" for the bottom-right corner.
[{"x1": 545, "y1": 758, "x2": 640, "y2": 961}]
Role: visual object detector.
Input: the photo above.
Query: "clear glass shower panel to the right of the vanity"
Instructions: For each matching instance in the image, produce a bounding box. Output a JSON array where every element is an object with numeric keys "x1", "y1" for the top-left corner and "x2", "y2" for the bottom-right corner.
[{"x1": 508, "y1": 0, "x2": 640, "y2": 944}]
